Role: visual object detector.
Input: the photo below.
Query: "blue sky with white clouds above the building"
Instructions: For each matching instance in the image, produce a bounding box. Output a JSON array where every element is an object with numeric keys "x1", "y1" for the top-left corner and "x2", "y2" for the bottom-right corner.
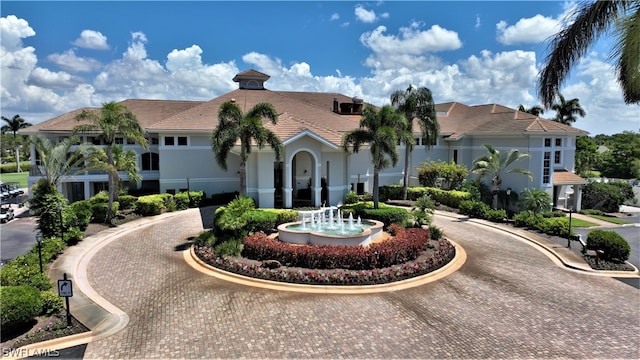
[{"x1": 0, "y1": 1, "x2": 640, "y2": 135}]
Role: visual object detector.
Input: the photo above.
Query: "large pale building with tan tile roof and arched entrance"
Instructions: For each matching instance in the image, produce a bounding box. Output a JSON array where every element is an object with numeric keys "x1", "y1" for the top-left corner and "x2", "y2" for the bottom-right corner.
[{"x1": 20, "y1": 70, "x2": 587, "y2": 210}]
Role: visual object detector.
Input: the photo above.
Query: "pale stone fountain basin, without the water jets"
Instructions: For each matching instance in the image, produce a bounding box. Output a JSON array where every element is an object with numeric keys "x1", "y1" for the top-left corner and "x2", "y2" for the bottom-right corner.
[{"x1": 278, "y1": 220, "x2": 384, "y2": 246}]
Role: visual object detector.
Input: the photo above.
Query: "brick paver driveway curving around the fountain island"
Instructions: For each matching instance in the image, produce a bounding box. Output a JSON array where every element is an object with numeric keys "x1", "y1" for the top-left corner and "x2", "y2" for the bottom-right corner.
[{"x1": 85, "y1": 212, "x2": 640, "y2": 359}]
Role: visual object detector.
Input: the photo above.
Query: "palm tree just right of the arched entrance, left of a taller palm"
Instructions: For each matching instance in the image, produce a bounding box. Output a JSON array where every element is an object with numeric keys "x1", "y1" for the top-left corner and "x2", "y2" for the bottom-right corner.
[{"x1": 342, "y1": 105, "x2": 413, "y2": 209}]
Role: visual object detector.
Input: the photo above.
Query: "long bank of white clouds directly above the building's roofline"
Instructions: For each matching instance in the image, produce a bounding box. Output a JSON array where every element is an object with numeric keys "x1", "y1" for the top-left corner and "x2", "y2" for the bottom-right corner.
[{"x1": 0, "y1": 13, "x2": 640, "y2": 134}]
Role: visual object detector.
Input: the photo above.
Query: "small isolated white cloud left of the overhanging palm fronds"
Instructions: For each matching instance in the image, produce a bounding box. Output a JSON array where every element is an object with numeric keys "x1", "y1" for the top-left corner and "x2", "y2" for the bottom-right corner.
[{"x1": 496, "y1": 15, "x2": 560, "y2": 45}]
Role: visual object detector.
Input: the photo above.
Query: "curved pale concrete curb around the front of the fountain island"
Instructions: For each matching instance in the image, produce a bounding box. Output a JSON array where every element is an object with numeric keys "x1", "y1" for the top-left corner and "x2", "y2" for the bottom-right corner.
[{"x1": 183, "y1": 239, "x2": 467, "y2": 294}]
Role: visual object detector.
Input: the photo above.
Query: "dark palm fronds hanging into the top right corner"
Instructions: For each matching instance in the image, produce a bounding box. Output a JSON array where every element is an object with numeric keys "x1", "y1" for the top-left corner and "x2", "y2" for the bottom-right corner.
[{"x1": 538, "y1": 0, "x2": 640, "y2": 108}]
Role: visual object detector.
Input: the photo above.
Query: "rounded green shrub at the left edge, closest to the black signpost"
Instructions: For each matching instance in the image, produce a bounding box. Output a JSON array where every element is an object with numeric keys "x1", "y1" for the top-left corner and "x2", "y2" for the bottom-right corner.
[{"x1": 0, "y1": 285, "x2": 42, "y2": 329}]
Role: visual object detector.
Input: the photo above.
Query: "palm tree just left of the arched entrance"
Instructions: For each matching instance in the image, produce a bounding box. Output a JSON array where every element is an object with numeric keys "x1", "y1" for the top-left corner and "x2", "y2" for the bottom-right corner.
[{"x1": 211, "y1": 101, "x2": 284, "y2": 196}]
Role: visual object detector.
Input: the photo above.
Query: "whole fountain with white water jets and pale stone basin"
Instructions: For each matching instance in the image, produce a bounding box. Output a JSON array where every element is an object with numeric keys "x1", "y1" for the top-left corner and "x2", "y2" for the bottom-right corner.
[{"x1": 278, "y1": 206, "x2": 384, "y2": 246}]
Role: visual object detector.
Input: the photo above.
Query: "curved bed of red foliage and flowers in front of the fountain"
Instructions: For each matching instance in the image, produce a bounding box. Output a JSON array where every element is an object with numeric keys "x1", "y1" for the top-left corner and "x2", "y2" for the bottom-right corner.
[{"x1": 195, "y1": 229, "x2": 455, "y2": 285}]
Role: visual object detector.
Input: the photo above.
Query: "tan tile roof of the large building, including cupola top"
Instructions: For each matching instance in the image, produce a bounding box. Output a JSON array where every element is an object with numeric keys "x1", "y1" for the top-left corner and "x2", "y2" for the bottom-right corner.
[{"x1": 21, "y1": 88, "x2": 588, "y2": 146}]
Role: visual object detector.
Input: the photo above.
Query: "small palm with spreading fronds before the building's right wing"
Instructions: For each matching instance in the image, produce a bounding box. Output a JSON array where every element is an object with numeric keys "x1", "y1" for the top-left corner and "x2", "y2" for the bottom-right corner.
[{"x1": 471, "y1": 144, "x2": 533, "y2": 209}]
